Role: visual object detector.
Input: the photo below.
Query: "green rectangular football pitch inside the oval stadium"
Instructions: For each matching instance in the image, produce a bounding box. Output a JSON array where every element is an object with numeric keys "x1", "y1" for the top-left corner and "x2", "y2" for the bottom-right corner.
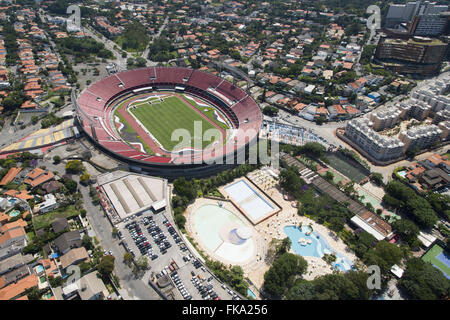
[{"x1": 128, "y1": 96, "x2": 221, "y2": 151}]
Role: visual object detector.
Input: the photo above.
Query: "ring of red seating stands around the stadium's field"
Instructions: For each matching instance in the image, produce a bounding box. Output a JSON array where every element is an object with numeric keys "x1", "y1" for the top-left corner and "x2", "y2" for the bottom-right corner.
[{"x1": 76, "y1": 67, "x2": 262, "y2": 169}]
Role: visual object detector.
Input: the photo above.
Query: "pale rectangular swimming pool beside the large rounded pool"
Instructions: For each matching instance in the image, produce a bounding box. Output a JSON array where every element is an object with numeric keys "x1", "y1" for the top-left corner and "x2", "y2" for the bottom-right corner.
[{"x1": 224, "y1": 180, "x2": 275, "y2": 221}]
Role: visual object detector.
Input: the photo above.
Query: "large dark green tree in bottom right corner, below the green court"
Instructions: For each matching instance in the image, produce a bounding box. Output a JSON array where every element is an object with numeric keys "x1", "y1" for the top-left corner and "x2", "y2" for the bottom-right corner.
[{"x1": 398, "y1": 258, "x2": 450, "y2": 300}]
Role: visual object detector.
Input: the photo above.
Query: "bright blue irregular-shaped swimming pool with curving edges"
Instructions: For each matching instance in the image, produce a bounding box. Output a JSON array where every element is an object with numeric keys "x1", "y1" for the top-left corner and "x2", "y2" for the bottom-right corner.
[{"x1": 283, "y1": 226, "x2": 353, "y2": 271}]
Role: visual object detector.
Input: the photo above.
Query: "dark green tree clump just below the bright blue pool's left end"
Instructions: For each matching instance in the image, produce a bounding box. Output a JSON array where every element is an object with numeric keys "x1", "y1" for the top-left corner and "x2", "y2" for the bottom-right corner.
[{"x1": 264, "y1": 252, "x2": 308, "y2": 297}]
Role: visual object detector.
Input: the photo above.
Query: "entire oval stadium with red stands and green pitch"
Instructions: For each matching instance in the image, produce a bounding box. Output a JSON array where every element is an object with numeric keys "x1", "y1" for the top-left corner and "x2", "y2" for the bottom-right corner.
[{"x1": 72, "y1": 67, "x2": 262, "y2": 178}]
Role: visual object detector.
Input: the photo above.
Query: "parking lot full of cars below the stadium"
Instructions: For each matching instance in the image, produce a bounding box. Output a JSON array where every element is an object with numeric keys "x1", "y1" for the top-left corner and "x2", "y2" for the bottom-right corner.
[{"x1": 117, "y1": 210, "x2": 243, "y2": 300}]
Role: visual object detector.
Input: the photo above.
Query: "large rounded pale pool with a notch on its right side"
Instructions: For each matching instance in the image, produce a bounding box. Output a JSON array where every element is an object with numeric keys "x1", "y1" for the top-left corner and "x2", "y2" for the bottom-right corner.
[{"x1": 193, "y1": 205, "x2": 256, "y2": 263}]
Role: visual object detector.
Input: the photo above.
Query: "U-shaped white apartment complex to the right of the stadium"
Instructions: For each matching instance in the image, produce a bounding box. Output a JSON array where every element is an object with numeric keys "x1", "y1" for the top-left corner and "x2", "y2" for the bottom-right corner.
[{"x1": 345, "y1": 74, "x2": 450, "y2": 161}]
